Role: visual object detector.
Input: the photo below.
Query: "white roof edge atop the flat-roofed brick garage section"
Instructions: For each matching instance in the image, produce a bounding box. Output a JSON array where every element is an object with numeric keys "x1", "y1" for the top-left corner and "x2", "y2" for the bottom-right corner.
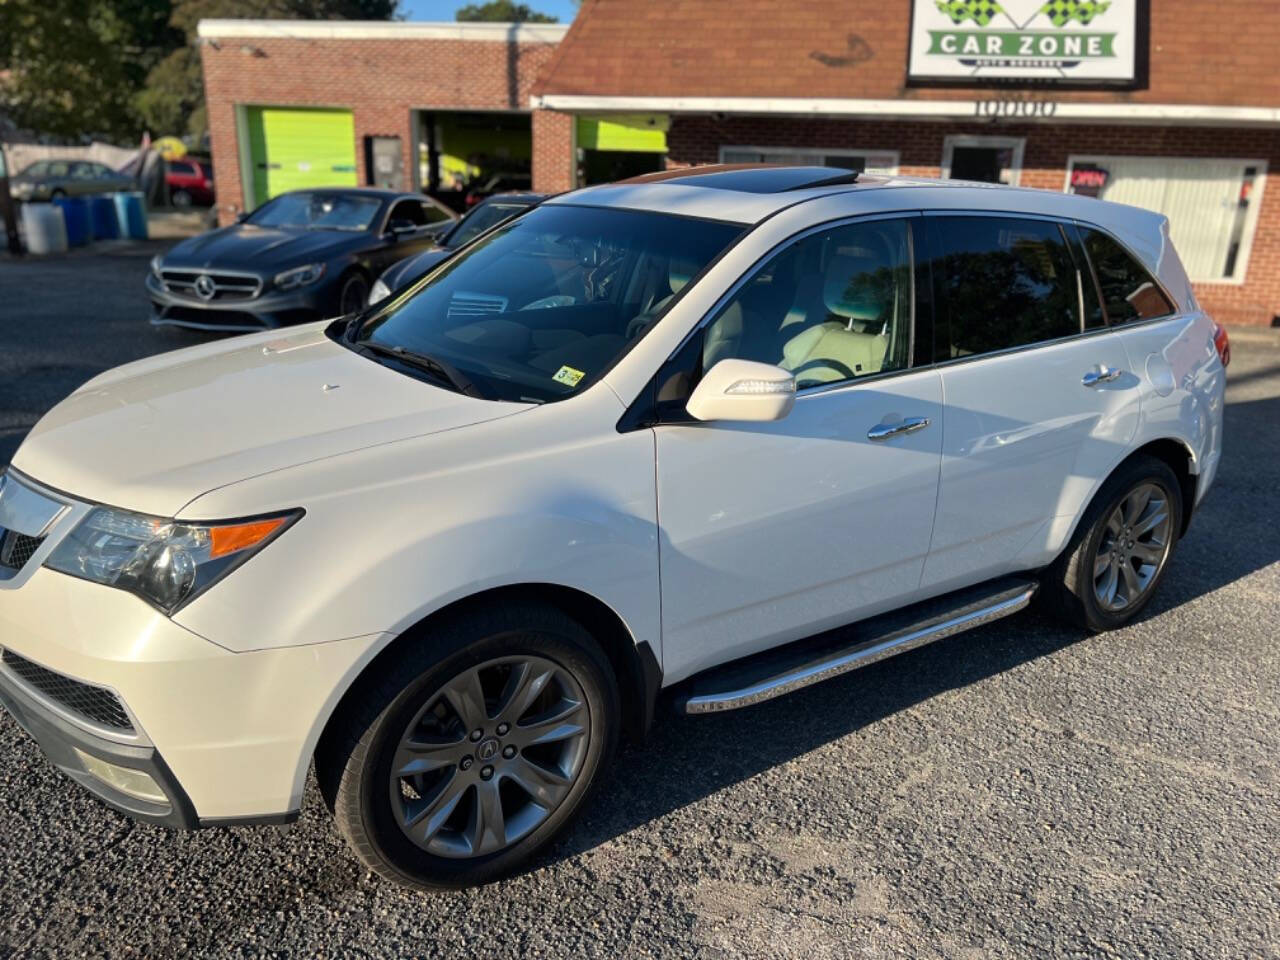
[{"x1": 196, "y1": 19, "x2": 570, "y2": 44}]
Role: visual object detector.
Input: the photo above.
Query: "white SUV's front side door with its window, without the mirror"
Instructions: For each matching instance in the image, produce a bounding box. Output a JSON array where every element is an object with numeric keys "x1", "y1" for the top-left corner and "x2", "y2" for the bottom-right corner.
[{"x1": 654, "y1": 218, "x2": 942, "y2": 681}]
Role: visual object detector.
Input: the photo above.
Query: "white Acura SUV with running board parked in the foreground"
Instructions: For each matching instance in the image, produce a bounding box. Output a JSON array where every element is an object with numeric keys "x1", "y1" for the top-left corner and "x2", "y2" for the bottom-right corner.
[{"x1": 0, "y1": 168, "x2": 1225, "y2": 887}]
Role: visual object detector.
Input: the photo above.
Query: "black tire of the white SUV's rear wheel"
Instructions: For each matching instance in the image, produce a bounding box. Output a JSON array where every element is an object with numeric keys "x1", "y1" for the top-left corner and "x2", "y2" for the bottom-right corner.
[{"x1": 1041, "y1": 454, "x2": 1183, "y2": 632}]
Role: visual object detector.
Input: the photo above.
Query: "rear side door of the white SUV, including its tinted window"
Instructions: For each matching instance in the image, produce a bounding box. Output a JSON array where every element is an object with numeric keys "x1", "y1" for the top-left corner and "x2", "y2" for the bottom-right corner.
[{"x1": 922, "y1": 212, "x2": 1140, "y2": 594}]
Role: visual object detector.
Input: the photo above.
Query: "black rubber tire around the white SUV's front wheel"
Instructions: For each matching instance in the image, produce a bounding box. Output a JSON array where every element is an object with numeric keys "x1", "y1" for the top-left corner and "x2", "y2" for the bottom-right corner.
[{"x1": 316, "y1": 604, "x2": 620, "y2": 890}]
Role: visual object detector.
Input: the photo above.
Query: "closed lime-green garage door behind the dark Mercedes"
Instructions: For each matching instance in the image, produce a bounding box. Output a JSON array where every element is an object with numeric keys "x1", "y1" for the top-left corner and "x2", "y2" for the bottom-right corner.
[{"x1": 247, "y1": 106, "x2": 356, "y2": 204}]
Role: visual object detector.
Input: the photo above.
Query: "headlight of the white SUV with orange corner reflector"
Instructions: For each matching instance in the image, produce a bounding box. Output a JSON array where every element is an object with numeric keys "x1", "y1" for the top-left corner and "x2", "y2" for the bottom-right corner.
[{"x1": 45, "y1": 507, "x2": 302, "y2": 613}]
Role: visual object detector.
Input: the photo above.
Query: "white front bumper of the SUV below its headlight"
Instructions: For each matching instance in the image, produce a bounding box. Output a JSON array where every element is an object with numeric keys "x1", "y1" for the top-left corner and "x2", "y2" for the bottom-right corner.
[{"x1": 0, "y1": 563, "x2": 380, "y2": 827}]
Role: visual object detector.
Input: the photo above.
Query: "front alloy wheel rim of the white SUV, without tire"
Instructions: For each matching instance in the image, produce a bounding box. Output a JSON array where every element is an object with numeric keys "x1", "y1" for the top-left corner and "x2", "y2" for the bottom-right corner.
[{"x1": 389, "y1": 655, "x2": 590, "y2": 859}]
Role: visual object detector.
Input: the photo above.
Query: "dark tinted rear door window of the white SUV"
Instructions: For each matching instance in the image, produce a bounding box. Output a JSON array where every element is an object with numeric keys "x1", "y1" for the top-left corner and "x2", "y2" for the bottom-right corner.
[{"x1": 932, "y1": 216, "x2": 1080, "y2": 360}]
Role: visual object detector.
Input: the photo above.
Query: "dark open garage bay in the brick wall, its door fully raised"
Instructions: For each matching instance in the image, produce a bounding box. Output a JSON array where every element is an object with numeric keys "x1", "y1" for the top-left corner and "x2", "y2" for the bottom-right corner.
[{"x1": 419, "y1": 110, "x2": 534, "y2": 212}]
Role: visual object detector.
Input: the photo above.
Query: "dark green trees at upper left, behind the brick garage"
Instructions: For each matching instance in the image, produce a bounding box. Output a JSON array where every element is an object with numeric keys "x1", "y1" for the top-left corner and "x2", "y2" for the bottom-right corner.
[{"x1": 0, "y1": 0, "x2": 399, "y2": 142}]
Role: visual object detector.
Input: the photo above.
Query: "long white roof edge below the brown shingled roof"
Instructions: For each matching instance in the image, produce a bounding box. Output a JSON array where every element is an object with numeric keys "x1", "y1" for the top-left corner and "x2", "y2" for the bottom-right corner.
[{"x1": 530, "y1": 93, "x2": 1280, "y2": 127}]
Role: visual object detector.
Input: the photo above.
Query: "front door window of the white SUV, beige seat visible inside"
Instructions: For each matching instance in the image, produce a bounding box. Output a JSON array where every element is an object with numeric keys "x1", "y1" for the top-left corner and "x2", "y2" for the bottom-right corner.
[{"x1": 701, "y1": 220, "x2": 913, "y2": 388}]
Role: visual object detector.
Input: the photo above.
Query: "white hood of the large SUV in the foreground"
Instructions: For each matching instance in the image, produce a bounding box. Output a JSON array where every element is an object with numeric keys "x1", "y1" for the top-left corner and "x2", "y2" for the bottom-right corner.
[{"x1": 13, "y1": 325, "x2": 529, "y2": 520}]
